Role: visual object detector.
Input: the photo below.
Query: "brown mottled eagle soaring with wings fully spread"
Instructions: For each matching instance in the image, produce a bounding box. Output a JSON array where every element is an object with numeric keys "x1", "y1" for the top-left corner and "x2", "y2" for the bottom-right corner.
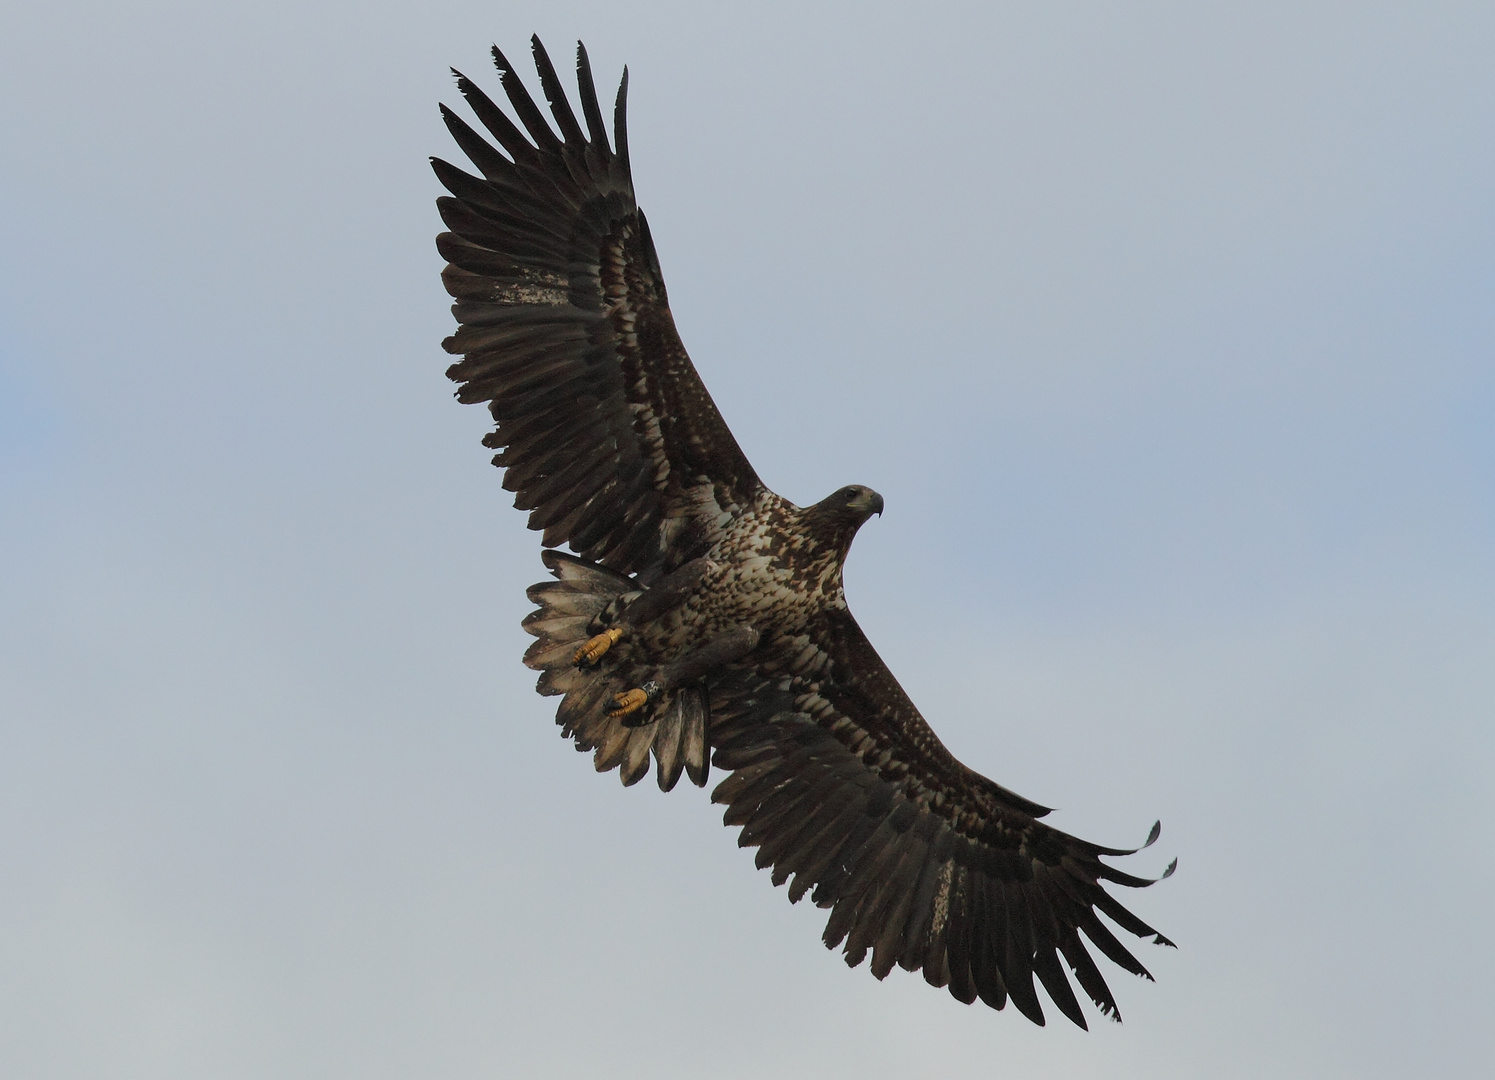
[{"x1": 431, "y1": 37, "x2": 1177, "y2": 1028}]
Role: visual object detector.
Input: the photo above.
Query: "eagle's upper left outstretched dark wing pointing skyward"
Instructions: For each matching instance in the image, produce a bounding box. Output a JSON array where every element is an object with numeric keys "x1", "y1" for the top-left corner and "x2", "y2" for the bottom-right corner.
[{"x1": 432, "y1": 37, "x2": 762, "y2": 579}]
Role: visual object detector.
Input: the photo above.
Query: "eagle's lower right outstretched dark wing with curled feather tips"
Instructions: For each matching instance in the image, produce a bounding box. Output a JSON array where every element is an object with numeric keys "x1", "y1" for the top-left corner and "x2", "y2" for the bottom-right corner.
[{"x1": 712, "y1": 610, "x2": 1177, "y2": 1028}]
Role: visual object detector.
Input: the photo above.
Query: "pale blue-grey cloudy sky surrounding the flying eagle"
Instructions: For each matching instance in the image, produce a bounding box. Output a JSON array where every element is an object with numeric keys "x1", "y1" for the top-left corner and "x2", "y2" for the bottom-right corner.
[{"x1": 0, "y1": 0, "x2": 1495, "y2": 1080}]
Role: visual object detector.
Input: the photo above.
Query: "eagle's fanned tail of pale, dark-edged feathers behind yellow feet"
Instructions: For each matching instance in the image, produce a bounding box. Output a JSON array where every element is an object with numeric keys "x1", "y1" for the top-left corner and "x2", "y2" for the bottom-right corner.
[{"x1": 523, "y1": 550, "x2": 710, "y2": 791}]
